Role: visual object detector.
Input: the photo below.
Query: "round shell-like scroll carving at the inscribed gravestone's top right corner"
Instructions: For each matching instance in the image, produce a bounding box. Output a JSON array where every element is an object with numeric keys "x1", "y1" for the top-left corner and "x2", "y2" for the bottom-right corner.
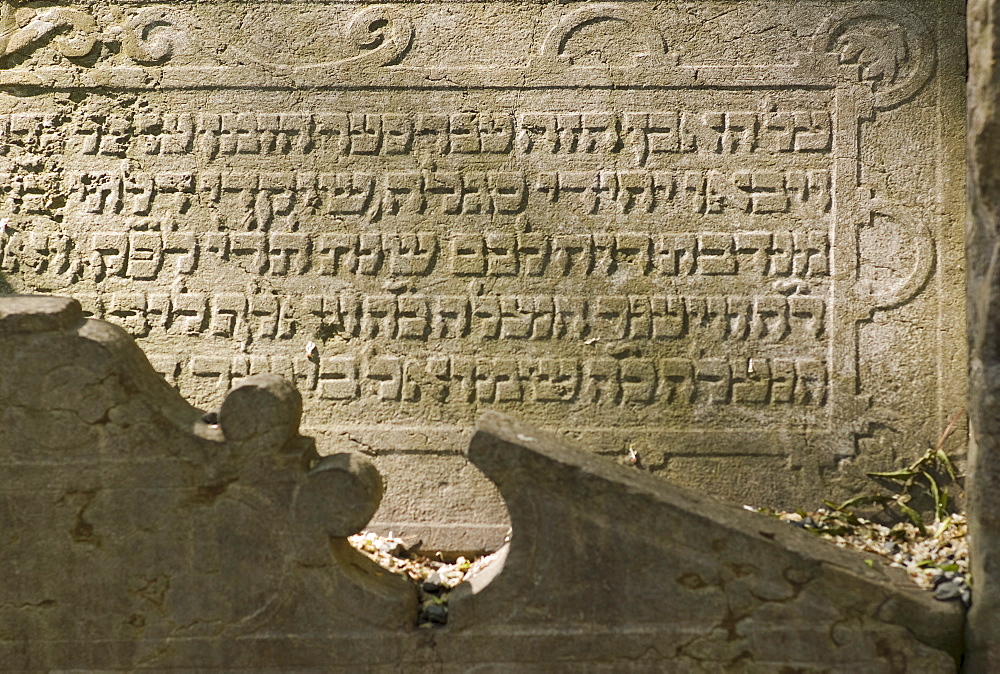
[{"x1": 816, "y1": 8, "x2": 935, "y2": 110}]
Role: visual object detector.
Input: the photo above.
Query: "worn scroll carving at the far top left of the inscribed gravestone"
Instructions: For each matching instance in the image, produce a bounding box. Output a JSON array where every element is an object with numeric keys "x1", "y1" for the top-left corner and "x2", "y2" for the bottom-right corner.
[{"x1": 0, "y1": 5, "x2": 97, "y2": 63}]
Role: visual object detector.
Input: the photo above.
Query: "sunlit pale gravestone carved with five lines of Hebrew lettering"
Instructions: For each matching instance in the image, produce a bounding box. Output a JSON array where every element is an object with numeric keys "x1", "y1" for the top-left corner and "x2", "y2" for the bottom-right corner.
[{"x1": 0, "y1": 0, "x2": 964, "y2": 549}]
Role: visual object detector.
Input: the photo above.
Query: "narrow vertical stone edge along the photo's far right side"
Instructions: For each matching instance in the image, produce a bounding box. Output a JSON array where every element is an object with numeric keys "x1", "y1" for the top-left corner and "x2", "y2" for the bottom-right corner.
[{"x1": 966, "y1": 0, "x2": 1000, "y2": 672}]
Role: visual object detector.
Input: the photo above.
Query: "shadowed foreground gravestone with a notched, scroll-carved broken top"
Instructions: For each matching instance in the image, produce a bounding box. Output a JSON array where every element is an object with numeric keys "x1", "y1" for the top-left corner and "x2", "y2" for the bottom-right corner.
[{"x1": 0, "y1": 298, "x2": 963, "y2": 673}]
